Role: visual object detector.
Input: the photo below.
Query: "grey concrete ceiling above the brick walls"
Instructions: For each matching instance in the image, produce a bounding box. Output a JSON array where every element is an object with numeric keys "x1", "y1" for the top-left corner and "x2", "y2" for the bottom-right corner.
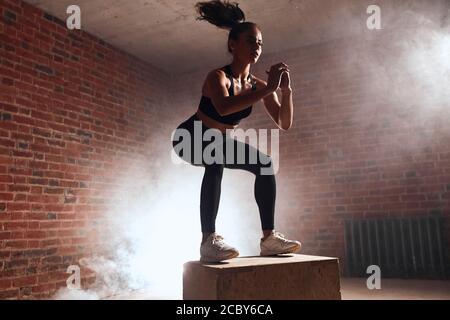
[{"x1": 25, "y1": 0, "x2": 450, "y2": 75}]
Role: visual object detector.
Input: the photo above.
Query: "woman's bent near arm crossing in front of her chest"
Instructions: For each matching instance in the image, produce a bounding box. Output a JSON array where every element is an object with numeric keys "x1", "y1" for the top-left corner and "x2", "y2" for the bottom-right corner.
[{"x1": 206, "y1": 70, "x2": 274, "y2": 116}]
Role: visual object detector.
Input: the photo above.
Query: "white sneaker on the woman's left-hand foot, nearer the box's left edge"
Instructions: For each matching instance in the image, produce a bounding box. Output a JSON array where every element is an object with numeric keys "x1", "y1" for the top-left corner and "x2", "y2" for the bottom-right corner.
[{"x1": 200, "y1": 232, "x2": 239, "y2": 262}]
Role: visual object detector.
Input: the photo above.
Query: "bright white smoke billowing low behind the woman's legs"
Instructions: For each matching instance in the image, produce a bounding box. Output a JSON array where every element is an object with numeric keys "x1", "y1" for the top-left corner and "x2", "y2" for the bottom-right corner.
[{"x1": 54, "y1": 141, "x2": 259, "y2": 300}]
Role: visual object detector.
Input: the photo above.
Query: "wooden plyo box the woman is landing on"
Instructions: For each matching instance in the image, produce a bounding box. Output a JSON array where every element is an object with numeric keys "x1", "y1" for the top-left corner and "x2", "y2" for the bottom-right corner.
[{"x1": 183, "y1": 254, "x2": 341, "y2": 300}]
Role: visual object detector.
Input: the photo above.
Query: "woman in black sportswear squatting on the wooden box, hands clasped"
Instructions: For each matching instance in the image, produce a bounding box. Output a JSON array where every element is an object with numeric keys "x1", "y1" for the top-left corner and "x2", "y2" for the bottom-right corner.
[{"x1": 172, "y1": 0, "x2": 301, "y2": 262}]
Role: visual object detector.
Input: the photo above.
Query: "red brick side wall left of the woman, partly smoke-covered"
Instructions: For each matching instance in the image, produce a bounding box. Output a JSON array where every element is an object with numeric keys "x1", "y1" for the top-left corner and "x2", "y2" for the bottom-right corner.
[{"x1": 0, "y1": 0, "x2": 174, "y2": 299}]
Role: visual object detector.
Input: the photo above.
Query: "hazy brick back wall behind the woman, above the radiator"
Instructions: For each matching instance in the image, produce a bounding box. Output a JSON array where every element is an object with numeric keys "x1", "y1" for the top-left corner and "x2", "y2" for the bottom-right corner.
[{"x1": 174, "y1": 34, "x2": 450, "y2": 268}]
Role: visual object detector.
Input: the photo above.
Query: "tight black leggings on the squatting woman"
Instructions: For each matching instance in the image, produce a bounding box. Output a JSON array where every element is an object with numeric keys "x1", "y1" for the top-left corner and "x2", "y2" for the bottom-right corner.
[{"x1": 172, "y1": 114, "x2": 276, "y2": 233}]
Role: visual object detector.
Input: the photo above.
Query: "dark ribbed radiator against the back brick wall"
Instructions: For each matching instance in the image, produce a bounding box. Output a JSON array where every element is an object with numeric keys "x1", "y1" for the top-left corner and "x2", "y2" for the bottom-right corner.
[{"x1": 344, "y1": 216, "x2": 449, "y2": 279}]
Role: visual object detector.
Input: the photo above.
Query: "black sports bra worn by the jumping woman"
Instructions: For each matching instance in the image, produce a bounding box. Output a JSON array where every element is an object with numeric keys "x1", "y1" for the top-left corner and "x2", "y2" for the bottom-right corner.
[{"x1": 198, "y1": 65, "x2": 256, "y2": 125}]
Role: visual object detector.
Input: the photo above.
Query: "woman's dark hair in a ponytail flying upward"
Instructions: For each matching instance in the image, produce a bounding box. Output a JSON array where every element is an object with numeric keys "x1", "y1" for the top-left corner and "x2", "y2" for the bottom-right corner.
[{"x1": 195, "y1": 0, "x2": 258, "y2": 53}]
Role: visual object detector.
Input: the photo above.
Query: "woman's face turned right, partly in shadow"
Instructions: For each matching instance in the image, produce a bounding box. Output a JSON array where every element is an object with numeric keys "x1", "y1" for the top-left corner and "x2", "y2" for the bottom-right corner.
[{"x1": 230, "y1": 27, "x2": 262, "y2": 63}]
